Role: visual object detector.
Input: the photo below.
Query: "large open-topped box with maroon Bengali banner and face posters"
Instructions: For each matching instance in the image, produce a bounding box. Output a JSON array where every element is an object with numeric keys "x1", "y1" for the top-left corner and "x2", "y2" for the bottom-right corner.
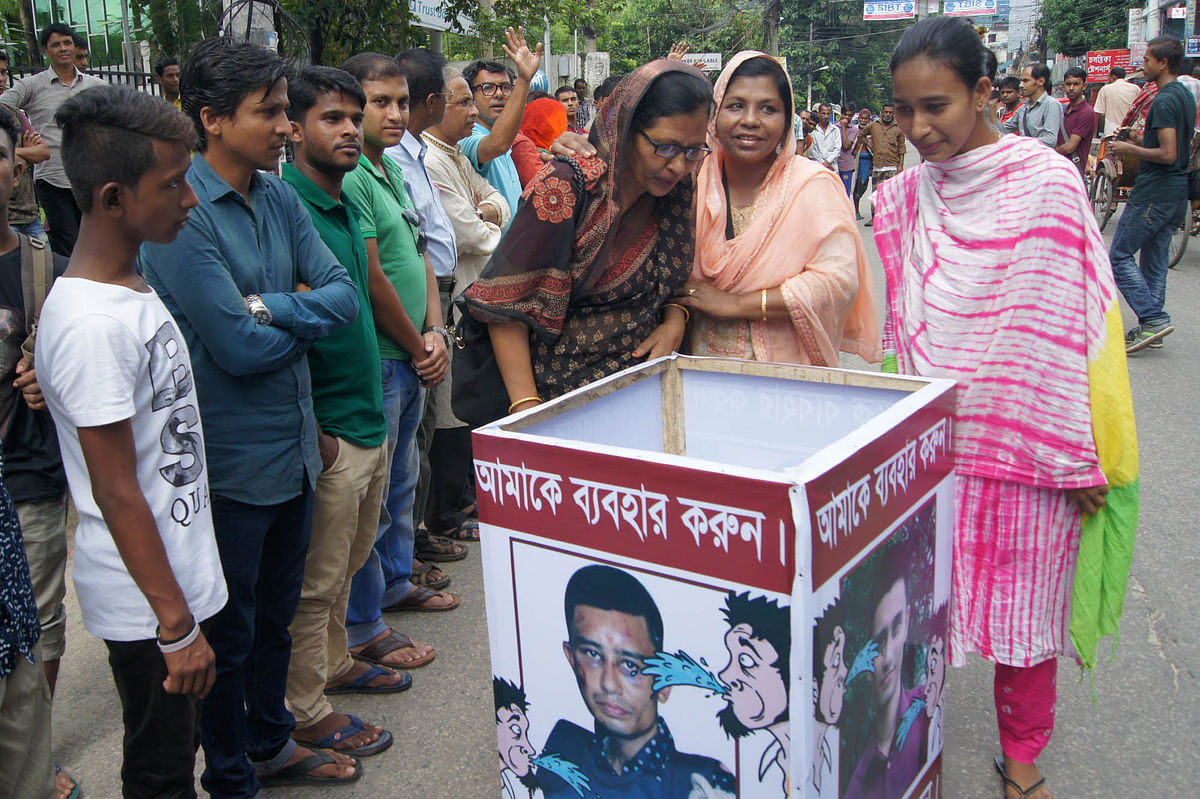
[{"x1": 474, "y1": 356, "x2": 954, "y2": 799}]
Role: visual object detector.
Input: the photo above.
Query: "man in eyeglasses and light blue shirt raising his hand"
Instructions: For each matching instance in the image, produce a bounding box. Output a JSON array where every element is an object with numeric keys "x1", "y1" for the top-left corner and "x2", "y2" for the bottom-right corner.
[{"x1": 460, "y1": 28, "x2": 541, "y2": 227}]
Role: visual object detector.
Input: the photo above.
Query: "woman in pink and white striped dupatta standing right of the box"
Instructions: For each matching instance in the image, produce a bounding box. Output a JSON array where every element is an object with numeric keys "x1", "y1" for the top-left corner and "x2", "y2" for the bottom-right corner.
[{"x1": 875, "y1": 17, "x2": 1136, "y2": 799}]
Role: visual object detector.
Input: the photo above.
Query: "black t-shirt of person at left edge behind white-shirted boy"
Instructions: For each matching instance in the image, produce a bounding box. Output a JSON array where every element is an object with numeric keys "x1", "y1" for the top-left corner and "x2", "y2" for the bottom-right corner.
[{"x1": 0, "y1": 247, "x2": 67, "y2": 503}]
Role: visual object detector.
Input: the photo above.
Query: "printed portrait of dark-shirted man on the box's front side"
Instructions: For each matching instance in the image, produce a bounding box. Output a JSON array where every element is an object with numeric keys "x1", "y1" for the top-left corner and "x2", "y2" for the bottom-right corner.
[{"x1": 538, "y1": 565, "x2": 734, "y2": 799}]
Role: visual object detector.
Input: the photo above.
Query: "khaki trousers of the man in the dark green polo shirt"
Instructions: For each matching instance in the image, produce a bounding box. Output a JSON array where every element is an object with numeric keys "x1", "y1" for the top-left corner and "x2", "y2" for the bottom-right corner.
[{"x1": 287, "y1": 439, "x2": 388, "y2": 729}]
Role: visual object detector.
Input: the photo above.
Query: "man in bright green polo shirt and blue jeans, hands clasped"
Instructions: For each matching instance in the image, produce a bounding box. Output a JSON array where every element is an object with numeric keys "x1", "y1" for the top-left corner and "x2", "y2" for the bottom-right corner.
[{"x1": 342, "y1": 53, "x2": 458, "y2": 668}]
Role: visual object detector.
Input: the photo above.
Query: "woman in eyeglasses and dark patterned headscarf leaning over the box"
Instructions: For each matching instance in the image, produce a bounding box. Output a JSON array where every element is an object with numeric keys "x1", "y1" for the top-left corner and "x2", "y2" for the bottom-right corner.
[{"x1": 464, "y1": 59, "x2": 713, "y2": 413}]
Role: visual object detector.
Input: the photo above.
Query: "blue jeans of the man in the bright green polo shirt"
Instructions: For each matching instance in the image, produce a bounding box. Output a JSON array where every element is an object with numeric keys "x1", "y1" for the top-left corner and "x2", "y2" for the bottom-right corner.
[{"x1": 346, "y1": 359, "x2": 425, "y2": 647}]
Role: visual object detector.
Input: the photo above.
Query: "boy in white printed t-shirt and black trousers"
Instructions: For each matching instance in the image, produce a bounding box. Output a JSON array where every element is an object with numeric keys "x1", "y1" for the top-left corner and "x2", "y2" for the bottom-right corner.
[{"x1": 36, "y1": 86, "x2": 227, "y2": 799}]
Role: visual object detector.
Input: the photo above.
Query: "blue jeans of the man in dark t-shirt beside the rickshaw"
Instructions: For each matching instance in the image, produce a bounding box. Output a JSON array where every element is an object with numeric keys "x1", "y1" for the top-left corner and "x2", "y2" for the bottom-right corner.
[{"x1": 1109, "y1": 198, "x2": 1188, "y2": 328}]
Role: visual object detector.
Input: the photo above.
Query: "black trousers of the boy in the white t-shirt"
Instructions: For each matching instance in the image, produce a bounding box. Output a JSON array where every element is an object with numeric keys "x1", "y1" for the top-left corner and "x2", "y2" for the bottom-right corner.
[{"x1": 104, "y1": 625, "x2": 208, "y2": 799}]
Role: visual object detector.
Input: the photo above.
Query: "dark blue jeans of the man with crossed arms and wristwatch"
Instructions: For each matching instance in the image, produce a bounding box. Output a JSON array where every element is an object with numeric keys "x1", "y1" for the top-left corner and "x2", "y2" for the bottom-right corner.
[{"x1": 200, "y1": 475, "x2": 312, "y2": 799}]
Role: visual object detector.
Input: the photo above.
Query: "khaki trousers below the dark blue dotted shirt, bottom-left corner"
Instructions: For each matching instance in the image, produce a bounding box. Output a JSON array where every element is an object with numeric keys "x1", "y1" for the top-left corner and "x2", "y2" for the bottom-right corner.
[{"x1": 0, "y1": 643, "x2": 54, "y2": 799}]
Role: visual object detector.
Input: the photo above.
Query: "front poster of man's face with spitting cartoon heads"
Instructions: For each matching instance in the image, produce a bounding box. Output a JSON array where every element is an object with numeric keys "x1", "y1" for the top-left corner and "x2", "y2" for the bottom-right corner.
[{"x1": 496, "y1": 543, "x2": 791, "y2": 799}]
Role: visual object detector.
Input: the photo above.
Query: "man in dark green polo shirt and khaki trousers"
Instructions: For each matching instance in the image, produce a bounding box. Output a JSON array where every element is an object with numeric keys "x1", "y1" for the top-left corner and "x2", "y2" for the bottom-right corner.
[{"x1": 283, "y1": 67, "x2": 413, "y2": 757}]
